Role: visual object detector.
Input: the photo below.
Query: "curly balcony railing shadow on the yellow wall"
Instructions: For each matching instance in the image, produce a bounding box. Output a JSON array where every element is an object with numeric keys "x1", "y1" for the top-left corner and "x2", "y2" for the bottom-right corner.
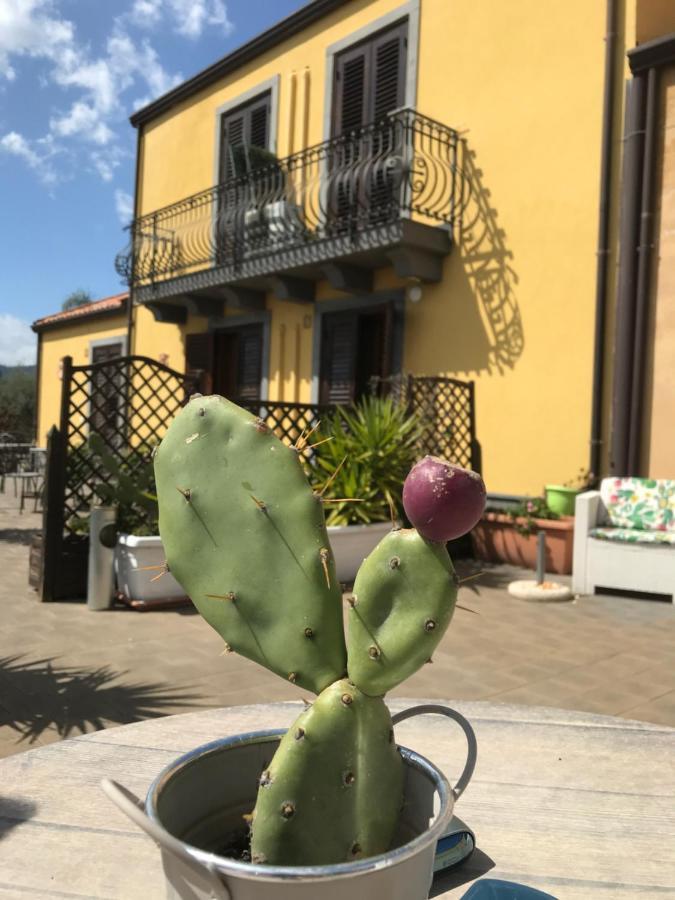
[{"x1": 458, "y1": 145, "x2": 525, "y2": 374}]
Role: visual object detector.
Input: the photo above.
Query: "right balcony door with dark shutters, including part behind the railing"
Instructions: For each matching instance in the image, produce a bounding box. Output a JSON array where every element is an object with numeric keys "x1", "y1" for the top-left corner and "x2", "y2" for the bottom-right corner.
[{"x1": 329, "y1": 20, "x2": 408, "y2": 231}]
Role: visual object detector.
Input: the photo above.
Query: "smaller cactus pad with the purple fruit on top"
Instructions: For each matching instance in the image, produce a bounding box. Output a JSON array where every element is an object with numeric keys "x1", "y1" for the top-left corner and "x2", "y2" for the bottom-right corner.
[{"x1": 347, "y1": 528, "x2": 457, "y2": 696}]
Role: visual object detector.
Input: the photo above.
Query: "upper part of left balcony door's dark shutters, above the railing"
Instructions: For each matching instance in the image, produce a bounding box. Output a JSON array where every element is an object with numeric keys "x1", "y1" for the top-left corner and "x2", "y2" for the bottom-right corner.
[{"x1": 218, "y1": 91, "x2": 272, "y2": 182}]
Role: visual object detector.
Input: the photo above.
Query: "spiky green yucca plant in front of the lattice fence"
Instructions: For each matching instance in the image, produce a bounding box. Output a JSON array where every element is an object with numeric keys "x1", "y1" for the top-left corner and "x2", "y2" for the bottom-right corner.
[{"x1": 308, "y1": 397, "x2": 420, "y2": 525}]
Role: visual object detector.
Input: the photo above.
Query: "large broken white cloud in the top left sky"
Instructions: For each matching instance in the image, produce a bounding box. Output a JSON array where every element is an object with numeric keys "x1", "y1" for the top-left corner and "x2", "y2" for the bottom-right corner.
[{"x1": 0, "y1": 0, "x2": 232, "y2": 192}]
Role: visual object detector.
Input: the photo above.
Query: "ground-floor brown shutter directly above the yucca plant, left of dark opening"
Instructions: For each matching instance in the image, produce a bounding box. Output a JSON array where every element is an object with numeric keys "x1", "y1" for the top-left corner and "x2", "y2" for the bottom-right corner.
[{"x1": 319, "y1": 313, "x2": 358, "y2": 404}]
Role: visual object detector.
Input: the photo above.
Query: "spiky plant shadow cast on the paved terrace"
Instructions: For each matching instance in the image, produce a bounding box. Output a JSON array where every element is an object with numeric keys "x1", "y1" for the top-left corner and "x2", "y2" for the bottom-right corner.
[{"x1": 0, "y1": 655, "x2": 202, "y2": 744}]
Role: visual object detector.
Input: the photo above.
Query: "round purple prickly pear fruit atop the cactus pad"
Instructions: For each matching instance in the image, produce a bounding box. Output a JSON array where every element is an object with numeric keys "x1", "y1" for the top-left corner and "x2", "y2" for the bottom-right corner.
[{"x1": 403, "y1": 456, "x2": 485, "y2": 542}]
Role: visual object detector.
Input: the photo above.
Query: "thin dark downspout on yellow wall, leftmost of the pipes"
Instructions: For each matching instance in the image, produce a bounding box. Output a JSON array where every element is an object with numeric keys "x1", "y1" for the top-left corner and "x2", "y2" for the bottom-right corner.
[{"x1": 588, "y1": 0, "x2": 617, "y2": 484}]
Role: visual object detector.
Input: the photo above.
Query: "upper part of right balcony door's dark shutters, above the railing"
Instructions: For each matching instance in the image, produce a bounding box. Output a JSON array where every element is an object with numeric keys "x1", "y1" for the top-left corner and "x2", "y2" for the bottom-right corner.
[{"x1": 332, "y1": 19, "x2": 408, "y2": 135}]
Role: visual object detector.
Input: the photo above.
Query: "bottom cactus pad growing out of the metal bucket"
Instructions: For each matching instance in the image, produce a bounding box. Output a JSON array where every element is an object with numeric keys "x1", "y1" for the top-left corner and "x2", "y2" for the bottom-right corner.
[{"x1": 251, "y1": 679, "x2": 403, "y2": 866}]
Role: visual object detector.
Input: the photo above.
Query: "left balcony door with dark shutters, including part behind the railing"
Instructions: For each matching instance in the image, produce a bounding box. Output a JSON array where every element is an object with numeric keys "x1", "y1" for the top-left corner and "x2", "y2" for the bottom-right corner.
[{"x1": 216, "y1": 92, "x2": 271, "y2": 265}]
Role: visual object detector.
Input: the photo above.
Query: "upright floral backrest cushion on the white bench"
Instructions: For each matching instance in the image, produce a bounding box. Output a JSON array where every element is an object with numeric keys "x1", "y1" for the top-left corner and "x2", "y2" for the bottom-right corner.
[{"x1": 600, "y1": 478, "x2": 675, "y2": 540}]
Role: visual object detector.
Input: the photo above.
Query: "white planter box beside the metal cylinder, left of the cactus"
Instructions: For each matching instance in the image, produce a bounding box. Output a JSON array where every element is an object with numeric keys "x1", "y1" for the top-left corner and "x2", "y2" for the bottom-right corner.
[{"x1": 115, "y1": 534, "x2": 185, "y2": 601}]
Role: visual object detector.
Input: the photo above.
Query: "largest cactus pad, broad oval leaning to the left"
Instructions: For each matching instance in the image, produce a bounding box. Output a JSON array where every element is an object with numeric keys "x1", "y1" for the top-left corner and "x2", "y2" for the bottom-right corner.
[{"x1": 155, "y1": 396, "x2": 346, "y2": 693}]
